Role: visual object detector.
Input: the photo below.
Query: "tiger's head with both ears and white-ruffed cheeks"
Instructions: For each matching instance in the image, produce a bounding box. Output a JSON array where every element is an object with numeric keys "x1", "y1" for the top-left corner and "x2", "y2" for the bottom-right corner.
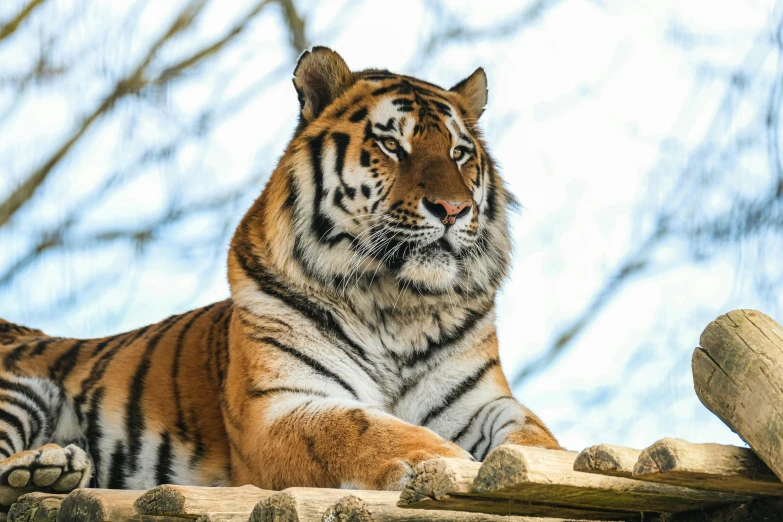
[{"x1": 234, "y1": 47, "x2": 513, "y2": 302}]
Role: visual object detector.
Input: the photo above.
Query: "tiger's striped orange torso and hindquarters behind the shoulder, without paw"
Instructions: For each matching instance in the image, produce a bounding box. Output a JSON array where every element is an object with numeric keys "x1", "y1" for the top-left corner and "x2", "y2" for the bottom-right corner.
[{"x1": 0, "y1": 300, "x2": 233, "y2": 489}]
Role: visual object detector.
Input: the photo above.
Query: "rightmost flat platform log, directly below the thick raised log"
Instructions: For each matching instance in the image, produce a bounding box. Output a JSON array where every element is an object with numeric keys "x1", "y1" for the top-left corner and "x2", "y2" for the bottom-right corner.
[{"x1": 633, "y1": 439, "x2": 783, "y2": 496}]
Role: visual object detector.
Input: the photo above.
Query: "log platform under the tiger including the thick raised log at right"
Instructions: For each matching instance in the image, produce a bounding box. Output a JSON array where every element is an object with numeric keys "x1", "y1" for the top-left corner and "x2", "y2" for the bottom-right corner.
[{"x1": 8, "y1": 310, "x2": 783, "y2": 522}]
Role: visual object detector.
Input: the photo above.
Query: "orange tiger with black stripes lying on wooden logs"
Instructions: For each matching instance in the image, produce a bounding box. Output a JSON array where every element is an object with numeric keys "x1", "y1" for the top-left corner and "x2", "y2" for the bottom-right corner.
[{"x1": 0, "y1": 47, "x2": 560, "y2": 506}]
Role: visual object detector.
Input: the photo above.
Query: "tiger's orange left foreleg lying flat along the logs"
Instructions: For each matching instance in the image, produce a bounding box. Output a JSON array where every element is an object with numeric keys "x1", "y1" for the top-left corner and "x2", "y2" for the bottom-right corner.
[{"x1": 229, "y1": 388, "x2": 471, "y2": 490}]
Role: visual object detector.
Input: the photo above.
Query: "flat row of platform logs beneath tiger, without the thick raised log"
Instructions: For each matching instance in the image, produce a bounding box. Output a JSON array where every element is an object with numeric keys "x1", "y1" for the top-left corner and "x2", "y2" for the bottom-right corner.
[{"x1": 9, "y1": 439, "x2": 783, "y2": 522}]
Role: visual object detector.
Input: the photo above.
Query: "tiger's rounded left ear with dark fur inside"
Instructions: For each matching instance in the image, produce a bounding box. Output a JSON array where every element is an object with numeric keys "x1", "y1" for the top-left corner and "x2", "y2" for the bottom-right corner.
[{"x1": 294, "y1": 46, "x2": 354, "y2": 123}]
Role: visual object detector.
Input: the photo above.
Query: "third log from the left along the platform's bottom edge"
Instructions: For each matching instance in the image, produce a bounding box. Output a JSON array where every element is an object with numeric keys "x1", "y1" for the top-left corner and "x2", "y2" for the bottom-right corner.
[{"x1": 135, "y1": 484, "x2": 275, "y2": 520}]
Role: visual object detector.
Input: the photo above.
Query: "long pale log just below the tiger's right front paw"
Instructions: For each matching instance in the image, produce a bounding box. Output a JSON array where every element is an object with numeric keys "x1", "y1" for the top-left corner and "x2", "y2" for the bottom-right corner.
[{"x1": 473, "y1": 445, "x2": 750, "y2": 518}]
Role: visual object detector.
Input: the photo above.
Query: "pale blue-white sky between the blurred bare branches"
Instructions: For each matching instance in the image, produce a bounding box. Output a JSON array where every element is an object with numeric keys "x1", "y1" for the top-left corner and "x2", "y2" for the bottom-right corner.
[{"x1": 0, "y1": 0, "x2": 773, "y2": 450}]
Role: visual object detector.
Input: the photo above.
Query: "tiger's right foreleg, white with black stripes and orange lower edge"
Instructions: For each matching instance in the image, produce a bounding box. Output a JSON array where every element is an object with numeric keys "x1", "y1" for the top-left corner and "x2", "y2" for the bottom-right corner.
[{"x1": 394, "y1": 333, "x2": 562, "y2": 460}]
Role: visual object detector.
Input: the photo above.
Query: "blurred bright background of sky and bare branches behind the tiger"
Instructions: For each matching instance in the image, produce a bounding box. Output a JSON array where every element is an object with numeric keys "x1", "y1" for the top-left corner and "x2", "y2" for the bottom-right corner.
[{"x1": 0, "y1": 0, "x2": 783, "y2": 449}]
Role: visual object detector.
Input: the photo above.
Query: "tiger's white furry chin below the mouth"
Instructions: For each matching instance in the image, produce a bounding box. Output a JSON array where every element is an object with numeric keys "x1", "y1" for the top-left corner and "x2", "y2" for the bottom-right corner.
[{"x1": 397, "y1": 248, "x2": 459, "y2": 292}]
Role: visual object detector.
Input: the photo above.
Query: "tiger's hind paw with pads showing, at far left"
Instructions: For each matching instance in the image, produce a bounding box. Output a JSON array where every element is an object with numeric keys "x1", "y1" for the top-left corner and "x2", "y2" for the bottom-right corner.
[{"x1": 0, "y1": 444, "x2": 92, "y2": 507}]
